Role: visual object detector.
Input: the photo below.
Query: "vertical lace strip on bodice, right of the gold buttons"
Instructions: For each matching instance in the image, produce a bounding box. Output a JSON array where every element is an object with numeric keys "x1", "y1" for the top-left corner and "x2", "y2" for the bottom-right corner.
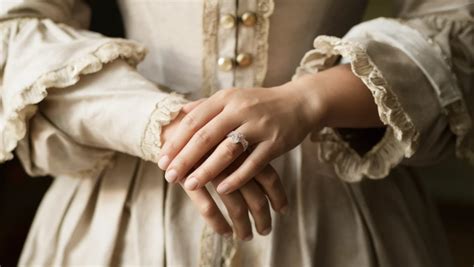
[{"x1": 254, "y1": 0, "x2": 275, "y2": 86}]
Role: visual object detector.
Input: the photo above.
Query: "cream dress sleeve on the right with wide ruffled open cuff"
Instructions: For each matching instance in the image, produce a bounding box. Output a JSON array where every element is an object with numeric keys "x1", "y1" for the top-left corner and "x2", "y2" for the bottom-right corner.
[{"x1": 294, "y1": 1, "x2": 474, "y2": 182}]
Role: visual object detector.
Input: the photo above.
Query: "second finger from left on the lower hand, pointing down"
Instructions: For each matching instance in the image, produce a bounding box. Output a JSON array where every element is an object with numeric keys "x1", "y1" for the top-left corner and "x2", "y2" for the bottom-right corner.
[{"x1": 213, "y1": 176, "x2": 253, "y2": 241}]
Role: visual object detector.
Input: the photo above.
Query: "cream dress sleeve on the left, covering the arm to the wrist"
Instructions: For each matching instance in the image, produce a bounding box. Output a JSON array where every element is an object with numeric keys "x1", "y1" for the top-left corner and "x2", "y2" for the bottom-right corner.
[{"x1": 0, "y1": 0, "x2": 185, "y2": 177}]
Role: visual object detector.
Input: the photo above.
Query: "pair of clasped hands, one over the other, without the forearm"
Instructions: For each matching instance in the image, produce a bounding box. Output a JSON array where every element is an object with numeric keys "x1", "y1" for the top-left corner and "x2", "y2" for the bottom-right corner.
[{"x1": 158, "y1": 81, "x2": 324, "y2": 240}]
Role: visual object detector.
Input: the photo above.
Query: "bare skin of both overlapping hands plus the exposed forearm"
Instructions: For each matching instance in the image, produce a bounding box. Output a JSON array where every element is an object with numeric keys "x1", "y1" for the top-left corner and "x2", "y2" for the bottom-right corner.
[{"x1": 159, "y1": 65, "x2": 383, "y2": 240}]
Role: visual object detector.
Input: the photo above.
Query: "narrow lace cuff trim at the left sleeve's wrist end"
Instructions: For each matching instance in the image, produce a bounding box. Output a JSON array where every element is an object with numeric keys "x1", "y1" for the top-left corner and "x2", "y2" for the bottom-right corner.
[{"x1": 141, "y1": 93, "x2": 187, "y2": 163}]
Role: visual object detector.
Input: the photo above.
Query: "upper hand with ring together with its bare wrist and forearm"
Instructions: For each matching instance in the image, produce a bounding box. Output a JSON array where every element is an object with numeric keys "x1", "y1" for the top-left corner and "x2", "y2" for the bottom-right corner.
[{"x1": 159, "y1": 65, "x2": 382, "y2": 194}]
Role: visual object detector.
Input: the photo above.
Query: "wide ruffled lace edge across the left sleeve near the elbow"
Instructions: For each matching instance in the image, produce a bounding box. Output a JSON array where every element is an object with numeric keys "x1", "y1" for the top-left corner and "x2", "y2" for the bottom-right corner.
[{"x1": 0, "y1": 27, "x2": 146, "y2": 165}]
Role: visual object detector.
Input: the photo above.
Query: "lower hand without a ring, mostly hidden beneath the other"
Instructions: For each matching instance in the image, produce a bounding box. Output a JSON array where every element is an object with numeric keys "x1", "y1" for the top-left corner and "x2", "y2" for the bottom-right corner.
[{"x1": 162, "y1": 101, "x2": 288, "y2": 241}]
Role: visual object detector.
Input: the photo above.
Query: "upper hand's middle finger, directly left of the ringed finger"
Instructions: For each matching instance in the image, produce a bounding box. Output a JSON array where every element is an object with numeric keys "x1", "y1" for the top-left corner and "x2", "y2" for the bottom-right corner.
[{"x1": 165, "y1": 113, "x2": 236, "y2": 182}]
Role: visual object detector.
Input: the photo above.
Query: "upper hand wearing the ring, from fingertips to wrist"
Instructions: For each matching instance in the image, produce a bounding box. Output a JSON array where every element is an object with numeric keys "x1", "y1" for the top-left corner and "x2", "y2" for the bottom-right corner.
[{"x1": 159, "y1": 79, "x2": 324, "y2": 194}]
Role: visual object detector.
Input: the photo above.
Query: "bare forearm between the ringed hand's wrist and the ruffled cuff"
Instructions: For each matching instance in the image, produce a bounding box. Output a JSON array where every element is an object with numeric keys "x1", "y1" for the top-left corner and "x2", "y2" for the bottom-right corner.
[{"x1": 285, "y1": 62, "x2": 383, "y2": 128}]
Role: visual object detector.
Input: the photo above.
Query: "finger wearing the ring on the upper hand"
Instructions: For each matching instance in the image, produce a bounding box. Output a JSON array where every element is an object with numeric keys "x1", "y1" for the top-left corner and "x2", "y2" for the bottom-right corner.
[{"x1": 184, "y1": 138, "x2": 244, "y2": 190}]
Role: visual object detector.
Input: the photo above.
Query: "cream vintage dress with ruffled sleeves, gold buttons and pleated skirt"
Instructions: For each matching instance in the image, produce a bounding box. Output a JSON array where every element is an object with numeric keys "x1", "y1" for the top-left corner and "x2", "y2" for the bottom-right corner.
[{"x1": 0, "y1": 0, "x2": 474, "y2": 267}]
